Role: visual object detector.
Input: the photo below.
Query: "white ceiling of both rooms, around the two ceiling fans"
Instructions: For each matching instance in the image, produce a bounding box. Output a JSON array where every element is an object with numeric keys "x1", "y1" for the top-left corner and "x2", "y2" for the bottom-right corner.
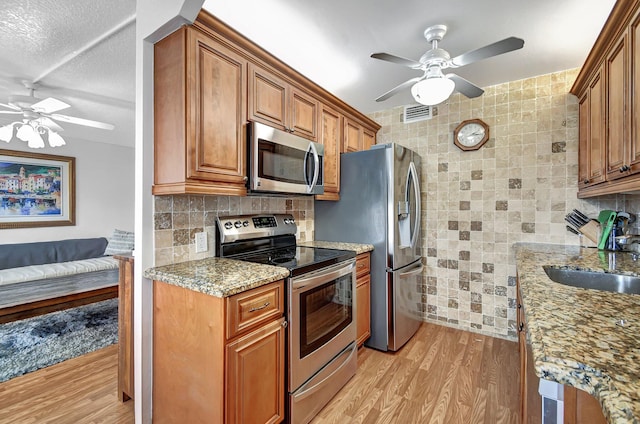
[{"x1": 0, "y1": 0, "x2": 615, "y2": 147}]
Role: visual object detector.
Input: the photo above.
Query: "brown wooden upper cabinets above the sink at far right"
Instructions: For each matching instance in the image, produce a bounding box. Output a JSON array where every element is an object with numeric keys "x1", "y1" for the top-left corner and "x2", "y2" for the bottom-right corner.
[{"x1": 571, "y1": 0, "x2": 640, "y2": 197}]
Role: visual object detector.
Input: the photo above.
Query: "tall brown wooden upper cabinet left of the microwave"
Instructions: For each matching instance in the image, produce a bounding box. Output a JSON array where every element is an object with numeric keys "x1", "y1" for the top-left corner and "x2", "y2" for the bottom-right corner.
[{"x1": 152, "y1": 27, "x2": 248, "y2": 195}]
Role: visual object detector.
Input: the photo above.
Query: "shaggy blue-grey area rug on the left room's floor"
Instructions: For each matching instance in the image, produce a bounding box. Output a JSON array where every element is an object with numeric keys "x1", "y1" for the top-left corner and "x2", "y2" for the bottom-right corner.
[{"x1": 0, "y1": 298, "x2": 118, "y2": 382}]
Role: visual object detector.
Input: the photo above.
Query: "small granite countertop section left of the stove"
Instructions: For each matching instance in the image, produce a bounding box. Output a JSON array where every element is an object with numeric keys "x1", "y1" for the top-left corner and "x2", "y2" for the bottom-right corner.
[{"x1": 144, "y1": 257, "x2": 289, "y2": 297}]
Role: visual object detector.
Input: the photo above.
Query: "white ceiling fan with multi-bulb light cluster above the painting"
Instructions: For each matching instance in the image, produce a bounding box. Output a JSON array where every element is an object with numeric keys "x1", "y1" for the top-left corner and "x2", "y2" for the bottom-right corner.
[{"x1": 0, "y1": 81, "x2": 115, "y2": 148}]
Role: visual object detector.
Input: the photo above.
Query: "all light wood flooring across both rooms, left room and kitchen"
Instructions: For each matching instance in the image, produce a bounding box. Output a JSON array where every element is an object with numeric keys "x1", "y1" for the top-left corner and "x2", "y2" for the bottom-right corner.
[{"x1": 0, "y1": 323, "x2": 520, "y2": 424}]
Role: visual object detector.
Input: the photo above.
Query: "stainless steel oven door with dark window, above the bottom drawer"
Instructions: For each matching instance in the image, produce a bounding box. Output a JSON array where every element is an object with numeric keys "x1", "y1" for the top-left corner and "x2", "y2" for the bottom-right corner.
[{"x1": 288, "y1": 259, "x2": 356, "y2": 392}]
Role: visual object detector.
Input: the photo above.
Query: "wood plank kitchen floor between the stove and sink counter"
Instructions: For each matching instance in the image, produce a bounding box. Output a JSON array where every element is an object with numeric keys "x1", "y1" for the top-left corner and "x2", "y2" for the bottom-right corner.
[{"x1": 311, "y1": 323, "x2": 520, "y2": 424}]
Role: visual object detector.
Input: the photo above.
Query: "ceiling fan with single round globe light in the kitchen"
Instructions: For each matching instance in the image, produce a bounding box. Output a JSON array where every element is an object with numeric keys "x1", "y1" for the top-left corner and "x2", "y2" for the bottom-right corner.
[{"x1": 371, "y1": 25, "x2": 524, "y2": 105}]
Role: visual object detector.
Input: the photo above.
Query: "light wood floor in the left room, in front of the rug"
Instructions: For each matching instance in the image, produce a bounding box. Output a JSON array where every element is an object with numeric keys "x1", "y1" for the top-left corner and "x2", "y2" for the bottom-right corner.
[{"x1": 0, "y1": 344, "x2": 134, "y2": 424}]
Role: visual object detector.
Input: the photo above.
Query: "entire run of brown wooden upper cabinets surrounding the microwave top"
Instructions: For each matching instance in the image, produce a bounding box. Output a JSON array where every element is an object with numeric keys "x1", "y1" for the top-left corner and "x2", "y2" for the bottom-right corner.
[{"x1": 152, "y1": 11, "x2": 380, "y2": 200}]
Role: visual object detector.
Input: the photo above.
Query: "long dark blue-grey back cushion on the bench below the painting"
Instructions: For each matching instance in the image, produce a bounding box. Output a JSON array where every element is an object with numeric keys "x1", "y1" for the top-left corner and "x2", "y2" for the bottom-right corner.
[{"x1": 0, "y1": 237, "x2": 107, "y2": 270}]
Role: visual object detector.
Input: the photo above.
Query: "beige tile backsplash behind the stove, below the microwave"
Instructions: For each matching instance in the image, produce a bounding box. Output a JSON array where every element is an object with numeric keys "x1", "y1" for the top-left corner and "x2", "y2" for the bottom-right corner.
[{"x1": 154, "y1": 195, "x2": 313, "y2": 266}]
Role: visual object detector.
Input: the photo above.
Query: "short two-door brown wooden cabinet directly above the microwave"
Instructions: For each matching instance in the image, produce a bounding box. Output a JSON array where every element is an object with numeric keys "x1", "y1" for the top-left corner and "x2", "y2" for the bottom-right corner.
[{"x1": 249, "y1": 63, "x2": 319, "y2": 141}]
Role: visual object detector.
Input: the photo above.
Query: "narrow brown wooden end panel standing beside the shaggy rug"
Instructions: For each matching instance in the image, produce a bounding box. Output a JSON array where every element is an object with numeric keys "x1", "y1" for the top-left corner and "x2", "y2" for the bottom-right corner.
[{"x1": 114, "y1": 255, "x2": 134, "y2": 402}]
